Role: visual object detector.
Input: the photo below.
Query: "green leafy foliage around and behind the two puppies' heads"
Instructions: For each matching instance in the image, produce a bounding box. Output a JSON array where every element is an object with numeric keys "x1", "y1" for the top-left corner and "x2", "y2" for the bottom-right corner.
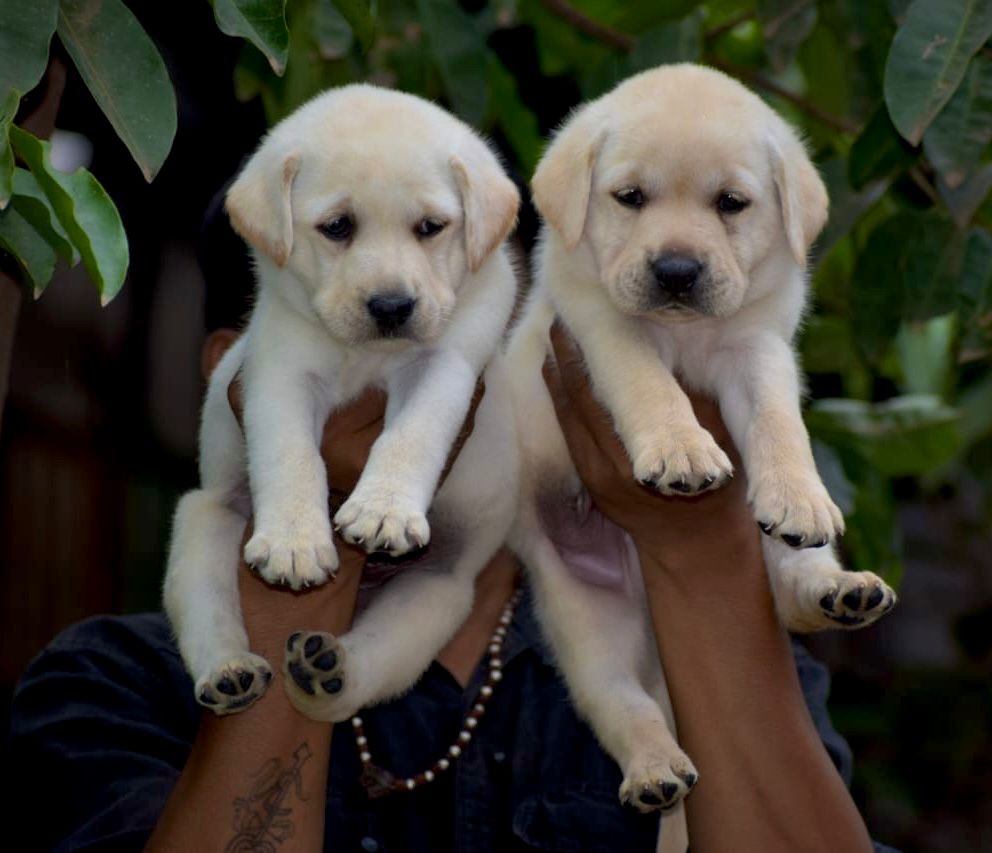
[{"x1": 0, "y1": 0, "x2": 992, "y2": 583}]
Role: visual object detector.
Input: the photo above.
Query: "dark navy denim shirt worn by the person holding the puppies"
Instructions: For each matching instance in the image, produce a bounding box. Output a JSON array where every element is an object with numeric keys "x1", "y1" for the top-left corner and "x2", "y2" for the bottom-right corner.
[{"x1": 6, "y1": 592, "x2": 900, "y2": 853}]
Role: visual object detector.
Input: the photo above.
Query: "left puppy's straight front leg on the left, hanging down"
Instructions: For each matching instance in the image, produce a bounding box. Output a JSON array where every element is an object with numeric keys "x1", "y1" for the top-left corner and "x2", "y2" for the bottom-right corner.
[{"x1": 244, "y1": 340, "x2": 338, "y2": 589}]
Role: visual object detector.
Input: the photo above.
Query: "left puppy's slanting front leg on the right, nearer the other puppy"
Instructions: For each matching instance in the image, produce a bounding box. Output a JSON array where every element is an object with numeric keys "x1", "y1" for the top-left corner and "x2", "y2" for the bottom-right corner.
[{"x1": 334, "y1": 350, "x2": 476, "y2": 556}]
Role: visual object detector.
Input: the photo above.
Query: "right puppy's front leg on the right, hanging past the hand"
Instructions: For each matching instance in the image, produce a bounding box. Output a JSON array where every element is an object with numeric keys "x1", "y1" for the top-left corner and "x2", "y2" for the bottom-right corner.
[{"x1": 717, "y1": 335, "x2": 844, "y2": 548}]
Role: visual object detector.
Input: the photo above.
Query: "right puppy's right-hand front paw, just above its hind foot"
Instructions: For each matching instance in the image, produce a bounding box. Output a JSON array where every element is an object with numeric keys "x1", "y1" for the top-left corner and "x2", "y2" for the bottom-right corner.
[{"x1": 748, "y1": 470, "x2": 844, "y2": 548}]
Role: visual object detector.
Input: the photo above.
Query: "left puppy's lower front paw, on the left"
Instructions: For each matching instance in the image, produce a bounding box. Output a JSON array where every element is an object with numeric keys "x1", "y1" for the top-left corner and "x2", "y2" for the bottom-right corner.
[{"x1": 245, "y1": 516, "x2": 338, "y2": 590}]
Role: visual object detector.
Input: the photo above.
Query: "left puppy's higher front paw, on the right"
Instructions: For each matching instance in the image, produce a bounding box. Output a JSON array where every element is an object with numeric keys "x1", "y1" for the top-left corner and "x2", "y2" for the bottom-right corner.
[{"x1": 334, "y1": 489, "x2": 431, "y2": 557}]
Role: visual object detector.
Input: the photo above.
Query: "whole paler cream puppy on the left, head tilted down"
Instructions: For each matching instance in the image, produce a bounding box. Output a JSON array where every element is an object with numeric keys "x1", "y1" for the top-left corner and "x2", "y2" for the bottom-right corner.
[{"x1": 164, "y1": 85, "x2": 519, "y2": 721}]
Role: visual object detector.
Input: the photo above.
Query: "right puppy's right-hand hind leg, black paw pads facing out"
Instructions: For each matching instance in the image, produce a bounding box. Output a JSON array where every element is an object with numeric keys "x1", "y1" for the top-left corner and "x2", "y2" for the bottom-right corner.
[{"x1": 762, "y1": 536, "x2": 897, "y2": 634}]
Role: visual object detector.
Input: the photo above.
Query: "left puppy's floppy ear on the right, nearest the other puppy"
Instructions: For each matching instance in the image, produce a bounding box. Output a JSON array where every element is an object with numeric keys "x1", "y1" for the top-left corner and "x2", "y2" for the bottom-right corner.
[{"x1": 449, "y1": 137, "x2": 520, "y2": 272}]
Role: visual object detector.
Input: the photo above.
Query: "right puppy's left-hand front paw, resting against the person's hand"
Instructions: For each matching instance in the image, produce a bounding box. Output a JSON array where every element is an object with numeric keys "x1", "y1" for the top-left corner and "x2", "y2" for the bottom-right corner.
[{"x1": 633, "y1": 425, "x2": 734, "y2": 495}]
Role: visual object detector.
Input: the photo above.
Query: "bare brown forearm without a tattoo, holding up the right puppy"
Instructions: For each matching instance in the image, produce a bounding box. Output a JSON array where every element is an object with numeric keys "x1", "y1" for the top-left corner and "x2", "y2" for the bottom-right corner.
[{"x1": 640, "y1": 530, "x2": 872, "y2": 853}]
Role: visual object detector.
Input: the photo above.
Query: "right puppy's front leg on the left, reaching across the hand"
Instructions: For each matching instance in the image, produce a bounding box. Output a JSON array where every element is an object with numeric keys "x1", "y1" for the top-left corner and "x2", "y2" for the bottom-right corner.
[{"x1": 560, "y1": 312, "x2": 733, "y2": 495}]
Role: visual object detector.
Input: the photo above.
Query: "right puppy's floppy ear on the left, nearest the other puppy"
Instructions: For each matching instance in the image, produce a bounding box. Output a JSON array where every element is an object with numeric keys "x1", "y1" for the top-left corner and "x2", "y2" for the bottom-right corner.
[{"x1": 531, "y1": 108, "x2": 604, "y2": 249}]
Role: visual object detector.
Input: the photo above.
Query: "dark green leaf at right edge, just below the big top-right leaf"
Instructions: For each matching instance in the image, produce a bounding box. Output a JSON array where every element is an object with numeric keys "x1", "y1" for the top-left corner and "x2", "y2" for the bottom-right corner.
[{"x1": 923, "y1": 53, "x2": 992, "y2": 189}]
